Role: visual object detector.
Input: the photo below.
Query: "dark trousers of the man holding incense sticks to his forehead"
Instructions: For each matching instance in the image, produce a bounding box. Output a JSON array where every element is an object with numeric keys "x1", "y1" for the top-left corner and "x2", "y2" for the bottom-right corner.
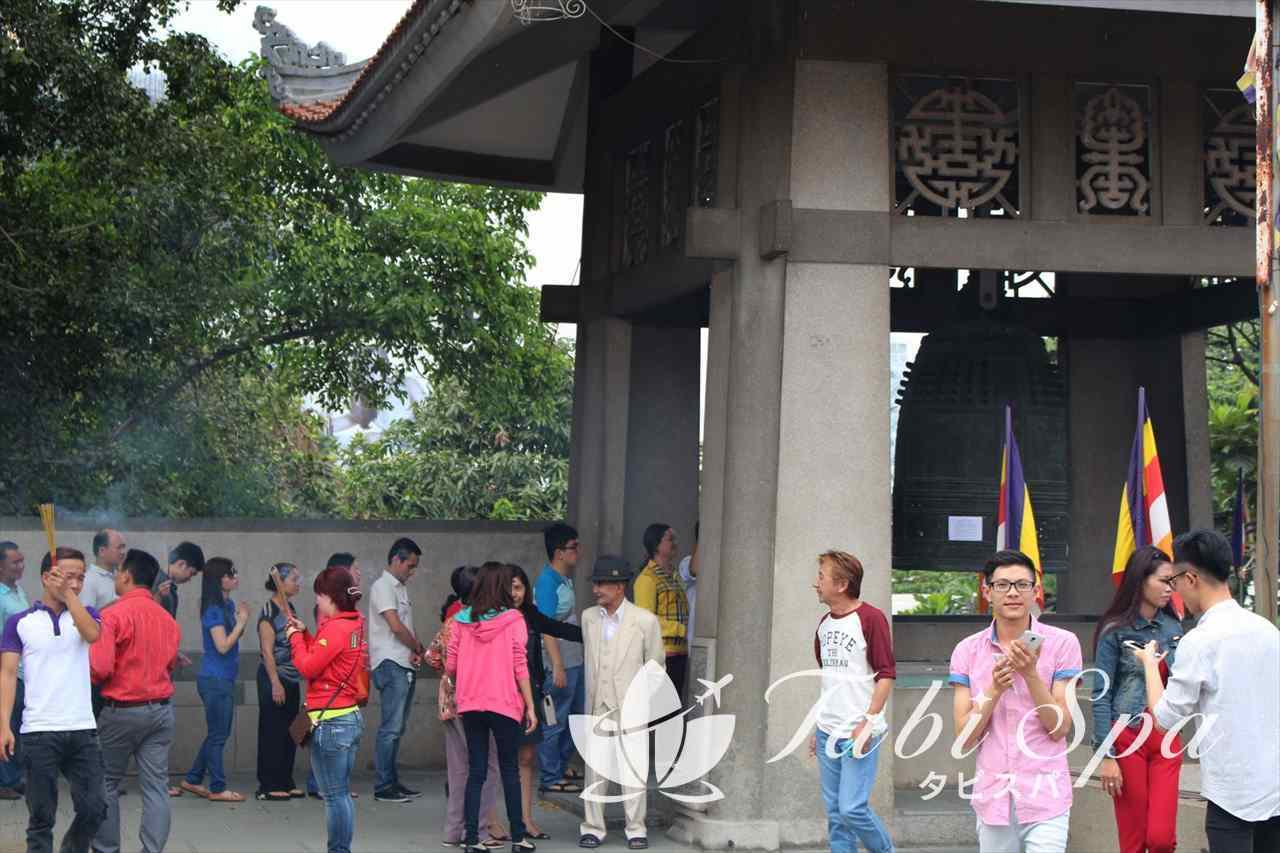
[{"x1": 22, "y1": 729, "x2": 106, "y2": 853}]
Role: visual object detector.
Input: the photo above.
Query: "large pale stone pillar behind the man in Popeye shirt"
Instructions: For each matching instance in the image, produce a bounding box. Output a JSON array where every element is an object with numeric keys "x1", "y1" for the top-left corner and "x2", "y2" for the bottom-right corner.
[{"x1": 672, "y1": 60, "x2": 893, "y2": 849}]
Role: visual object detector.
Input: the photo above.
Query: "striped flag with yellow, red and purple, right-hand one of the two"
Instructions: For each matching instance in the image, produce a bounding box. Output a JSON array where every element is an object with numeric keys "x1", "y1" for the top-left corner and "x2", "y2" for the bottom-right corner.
[{"x1": 1111, "y1": 388, "x2": 1183, "y2": 615}]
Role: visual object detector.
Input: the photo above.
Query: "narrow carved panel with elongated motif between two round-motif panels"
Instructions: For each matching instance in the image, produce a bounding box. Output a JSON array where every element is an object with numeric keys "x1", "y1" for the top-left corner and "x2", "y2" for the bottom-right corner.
[{"x1": 1075, "y1": 83, "x2": 1152, "y2": 216}]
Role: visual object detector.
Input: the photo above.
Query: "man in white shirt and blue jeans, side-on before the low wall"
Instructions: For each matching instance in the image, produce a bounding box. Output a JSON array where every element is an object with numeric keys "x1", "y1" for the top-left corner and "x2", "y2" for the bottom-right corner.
[{"x1": 369, "y1": 539, "x2": 425, "y2": 803}]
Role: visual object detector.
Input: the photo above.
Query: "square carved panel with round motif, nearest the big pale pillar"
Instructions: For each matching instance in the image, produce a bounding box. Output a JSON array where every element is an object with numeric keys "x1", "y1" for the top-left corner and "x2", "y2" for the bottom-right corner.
[{"x1": 893, "y1": 74, "x2": 1021, "y2": 216}]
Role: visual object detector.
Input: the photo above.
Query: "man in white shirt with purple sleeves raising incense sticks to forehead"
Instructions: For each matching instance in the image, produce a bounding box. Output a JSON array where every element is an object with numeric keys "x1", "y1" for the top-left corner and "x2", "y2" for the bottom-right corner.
[{"x1": 0, "y1": 548, "x2": 106, "y2": 853}]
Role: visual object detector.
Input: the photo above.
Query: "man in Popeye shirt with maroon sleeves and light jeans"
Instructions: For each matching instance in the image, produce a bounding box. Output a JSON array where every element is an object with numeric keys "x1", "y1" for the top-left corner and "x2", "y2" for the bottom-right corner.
[{"x1": 809, "y1": 551, "x2": 897, "y2": 853}]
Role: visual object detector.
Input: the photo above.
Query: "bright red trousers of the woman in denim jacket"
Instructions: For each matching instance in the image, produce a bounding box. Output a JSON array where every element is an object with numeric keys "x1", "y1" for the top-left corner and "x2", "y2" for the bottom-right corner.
[{"x1": 1112, "y1": 725, "x2": 1183, "y2": 853}]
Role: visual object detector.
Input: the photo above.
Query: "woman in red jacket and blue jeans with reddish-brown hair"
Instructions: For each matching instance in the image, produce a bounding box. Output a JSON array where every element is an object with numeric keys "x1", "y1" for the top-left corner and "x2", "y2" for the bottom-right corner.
[{"x1": 285, "y1": 566, "x2": 369, "y2": 853}]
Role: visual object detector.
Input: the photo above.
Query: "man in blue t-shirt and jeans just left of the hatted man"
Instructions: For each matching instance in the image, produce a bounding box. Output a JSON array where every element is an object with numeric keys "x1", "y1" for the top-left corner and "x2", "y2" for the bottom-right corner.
[{"x1": 534, "y1": 524, "x2": 586, "y2": 794}]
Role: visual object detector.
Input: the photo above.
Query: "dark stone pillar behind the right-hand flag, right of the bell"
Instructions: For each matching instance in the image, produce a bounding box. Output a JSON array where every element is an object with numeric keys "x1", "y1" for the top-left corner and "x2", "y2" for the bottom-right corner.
[{"x1": 1057, "y1": 274, "x2": 1192, "y2": 613}]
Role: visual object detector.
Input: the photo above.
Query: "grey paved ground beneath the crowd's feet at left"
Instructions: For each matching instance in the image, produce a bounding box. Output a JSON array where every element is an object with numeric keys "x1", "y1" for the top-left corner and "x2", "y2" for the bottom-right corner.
[{"x1": 0, "y1": 774, "x2": 966, "y2": 853}]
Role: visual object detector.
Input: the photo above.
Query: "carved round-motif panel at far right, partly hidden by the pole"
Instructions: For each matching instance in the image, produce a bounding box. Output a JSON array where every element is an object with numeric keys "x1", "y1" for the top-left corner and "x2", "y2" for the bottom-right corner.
[{"x1": 1203, "y1": 88, "x2": 1257, "y2": 227}]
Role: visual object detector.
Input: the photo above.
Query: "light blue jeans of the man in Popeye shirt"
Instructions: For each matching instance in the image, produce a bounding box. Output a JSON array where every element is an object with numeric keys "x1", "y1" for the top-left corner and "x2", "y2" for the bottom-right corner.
[{"x1": 818, "y1": 729, "x2": 893, "y2": 853}]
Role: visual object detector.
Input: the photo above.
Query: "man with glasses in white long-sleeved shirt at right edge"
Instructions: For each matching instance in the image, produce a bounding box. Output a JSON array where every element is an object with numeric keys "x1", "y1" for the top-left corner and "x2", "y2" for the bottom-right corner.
[{"x1": 1134, "y1": 530, "x2": 1280, "y2": 853}]
